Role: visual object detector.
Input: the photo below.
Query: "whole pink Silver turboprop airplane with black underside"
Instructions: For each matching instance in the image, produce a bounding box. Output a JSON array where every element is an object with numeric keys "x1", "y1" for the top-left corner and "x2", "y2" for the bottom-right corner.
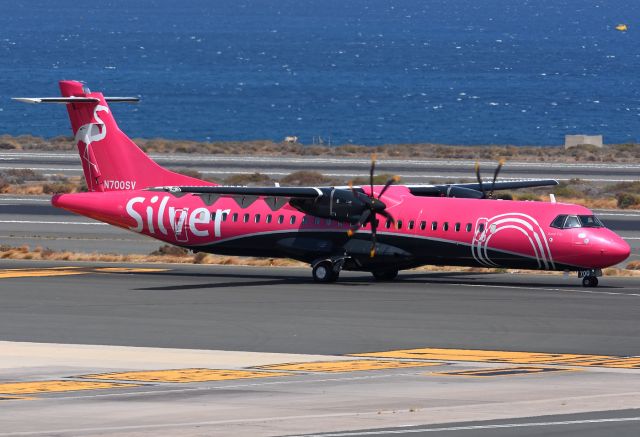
[{"x1": 16, "y1": 81, "x2": 630, "y2": 287}]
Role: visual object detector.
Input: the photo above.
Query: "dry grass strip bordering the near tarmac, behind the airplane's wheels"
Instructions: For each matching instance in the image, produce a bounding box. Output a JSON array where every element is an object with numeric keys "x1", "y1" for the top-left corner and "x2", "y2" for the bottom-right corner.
[{"x1": 0, "y1": 245, "x2": 640, "y2": 276}]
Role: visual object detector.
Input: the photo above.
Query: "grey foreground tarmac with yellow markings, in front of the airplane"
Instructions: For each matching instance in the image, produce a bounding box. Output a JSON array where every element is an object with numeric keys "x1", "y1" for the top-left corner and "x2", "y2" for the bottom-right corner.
[{"x1": 0, "y1": 260, "x2": 640, "y2": 436}]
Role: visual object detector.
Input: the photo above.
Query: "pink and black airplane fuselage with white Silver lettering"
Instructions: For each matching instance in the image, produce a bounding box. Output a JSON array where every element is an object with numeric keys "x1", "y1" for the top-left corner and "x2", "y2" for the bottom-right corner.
[{"x1": 52, "y1": 186, "x2": 630, "y2": 270}]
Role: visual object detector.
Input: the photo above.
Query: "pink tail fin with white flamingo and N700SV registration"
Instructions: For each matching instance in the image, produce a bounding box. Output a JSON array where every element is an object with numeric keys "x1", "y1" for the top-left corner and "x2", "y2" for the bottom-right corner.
[{"x1": 18, "y1": 81, "x2": 215, "y2": 191}]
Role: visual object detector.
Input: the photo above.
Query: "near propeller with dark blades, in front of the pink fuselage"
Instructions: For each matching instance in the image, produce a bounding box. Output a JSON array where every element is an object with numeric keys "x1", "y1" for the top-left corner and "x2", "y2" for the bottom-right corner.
[{"x1": 347, "y1": 154, "x2": 400, "y2": 258}]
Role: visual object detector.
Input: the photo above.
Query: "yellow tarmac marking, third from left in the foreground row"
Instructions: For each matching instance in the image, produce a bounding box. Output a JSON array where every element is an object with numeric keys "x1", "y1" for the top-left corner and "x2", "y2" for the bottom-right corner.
[{"x1": 258, "y1": 360, "x2": 443, "y2": 372}]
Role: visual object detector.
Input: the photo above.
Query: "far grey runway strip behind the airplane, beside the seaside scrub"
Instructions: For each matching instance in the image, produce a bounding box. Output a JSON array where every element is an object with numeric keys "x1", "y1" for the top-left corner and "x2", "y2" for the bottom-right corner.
[{"x1": 0, "y1": 151, "x2": 640, "y2": 183}]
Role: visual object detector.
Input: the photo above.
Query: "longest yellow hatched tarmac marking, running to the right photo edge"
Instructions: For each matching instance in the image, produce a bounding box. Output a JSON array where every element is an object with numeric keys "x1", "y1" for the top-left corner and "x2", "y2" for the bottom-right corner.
[{"x1": 352, "y1": 348, "x2": 640, "y2": 369}]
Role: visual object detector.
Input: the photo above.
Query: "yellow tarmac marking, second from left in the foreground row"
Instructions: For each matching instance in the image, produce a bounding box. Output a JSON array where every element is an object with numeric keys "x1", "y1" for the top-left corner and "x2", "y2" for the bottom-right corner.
[{"x1": 79, "y1": 369, "x2": 293, "y2": 382}]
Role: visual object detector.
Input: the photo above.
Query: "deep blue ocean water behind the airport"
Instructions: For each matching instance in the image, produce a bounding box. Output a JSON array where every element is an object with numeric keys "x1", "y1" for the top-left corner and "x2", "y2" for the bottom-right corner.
[{"x1": 0, "y1": 0, "x2": 640, "y2": 145}]
